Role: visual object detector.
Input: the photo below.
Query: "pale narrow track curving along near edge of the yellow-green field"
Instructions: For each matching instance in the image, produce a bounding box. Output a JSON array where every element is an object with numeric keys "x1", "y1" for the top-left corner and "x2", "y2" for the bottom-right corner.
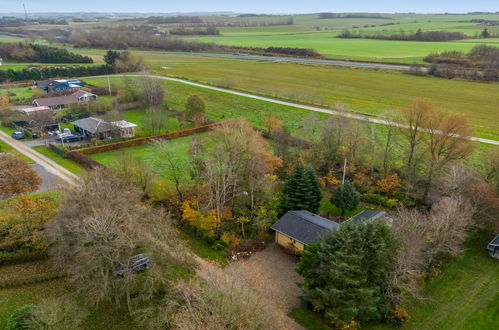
[{"x1": 114, "y1": 74, "x2": 499, "y2": 146}]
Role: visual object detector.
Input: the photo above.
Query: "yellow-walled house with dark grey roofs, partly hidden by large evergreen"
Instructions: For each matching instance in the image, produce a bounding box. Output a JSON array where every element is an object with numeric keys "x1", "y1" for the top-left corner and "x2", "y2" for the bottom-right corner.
[{"x1": 270, "y1": 210, "x2": 390, "y2": 252}]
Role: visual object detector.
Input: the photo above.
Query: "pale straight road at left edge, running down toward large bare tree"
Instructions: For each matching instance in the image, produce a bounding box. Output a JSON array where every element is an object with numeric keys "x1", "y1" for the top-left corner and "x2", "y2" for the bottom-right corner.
[{"x1": 0, "y1": 131, "x2": 78, "y2": 184}]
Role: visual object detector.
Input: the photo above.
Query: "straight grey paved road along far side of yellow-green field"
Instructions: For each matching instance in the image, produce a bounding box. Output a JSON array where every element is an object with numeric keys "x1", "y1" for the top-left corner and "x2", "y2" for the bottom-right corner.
[{"x1": 134, "y1": 50, "x2": 418, "y2": 71}]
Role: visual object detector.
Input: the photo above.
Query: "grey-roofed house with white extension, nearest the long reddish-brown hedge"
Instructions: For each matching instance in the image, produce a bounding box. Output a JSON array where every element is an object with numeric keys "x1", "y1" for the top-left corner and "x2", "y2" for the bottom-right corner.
[{"x1": 72, "y1": 117, "x2": 137, "y2": 140}]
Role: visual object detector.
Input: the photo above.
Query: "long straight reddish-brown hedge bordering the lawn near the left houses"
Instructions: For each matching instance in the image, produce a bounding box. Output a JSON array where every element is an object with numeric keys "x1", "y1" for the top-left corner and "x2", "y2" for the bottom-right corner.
[{"x1": 76, "y1": 123, "x2": 220, "y2": 155}]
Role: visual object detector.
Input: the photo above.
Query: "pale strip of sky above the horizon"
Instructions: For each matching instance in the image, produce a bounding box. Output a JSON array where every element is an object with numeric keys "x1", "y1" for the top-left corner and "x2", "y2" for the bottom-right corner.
[{"x1": 0, "y1": 0, "x2": 499, "y2": 13}]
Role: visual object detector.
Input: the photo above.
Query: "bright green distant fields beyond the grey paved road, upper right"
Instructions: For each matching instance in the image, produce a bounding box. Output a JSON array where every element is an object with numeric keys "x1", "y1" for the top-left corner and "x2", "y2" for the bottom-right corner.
[{"x1": 187, "y1": 14, "x2": 499, "y2": 63}]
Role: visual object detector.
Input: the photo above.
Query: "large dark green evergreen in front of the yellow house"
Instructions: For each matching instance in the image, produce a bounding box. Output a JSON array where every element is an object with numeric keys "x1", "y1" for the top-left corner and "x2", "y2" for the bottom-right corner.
[{"x1": 297, "y1": 221, "x2": 398, "y2": 324}]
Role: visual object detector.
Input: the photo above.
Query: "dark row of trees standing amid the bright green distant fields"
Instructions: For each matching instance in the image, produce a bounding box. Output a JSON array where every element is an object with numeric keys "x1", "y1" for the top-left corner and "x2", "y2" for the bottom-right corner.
[{"x1": 338, "y1": 29, "x2": 469, "y2": 41}]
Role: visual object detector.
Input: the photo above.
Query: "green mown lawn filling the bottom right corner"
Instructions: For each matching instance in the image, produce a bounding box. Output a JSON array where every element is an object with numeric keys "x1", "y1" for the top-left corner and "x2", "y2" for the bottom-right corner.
[{"x1": 394, "y1": 232, "x2": 499, "y2": 330}]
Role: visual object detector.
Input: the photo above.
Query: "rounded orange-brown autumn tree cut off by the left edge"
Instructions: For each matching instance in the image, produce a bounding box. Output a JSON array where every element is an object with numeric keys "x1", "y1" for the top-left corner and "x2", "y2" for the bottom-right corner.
[{"x1": 0, "y1": 153, "x2": 42, "y2": 197}]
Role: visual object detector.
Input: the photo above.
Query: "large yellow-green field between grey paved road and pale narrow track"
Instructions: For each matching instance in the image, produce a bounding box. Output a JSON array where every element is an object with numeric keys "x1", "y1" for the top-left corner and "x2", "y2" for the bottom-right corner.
[{"x1": 137, "y1": 54, "x2": 499, "y2": 139}]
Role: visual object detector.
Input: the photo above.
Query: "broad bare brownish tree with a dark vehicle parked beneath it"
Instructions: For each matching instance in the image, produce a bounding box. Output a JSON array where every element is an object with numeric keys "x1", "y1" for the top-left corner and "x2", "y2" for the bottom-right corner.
[{"x1": 48, "y1": 169, "x2": 190, "y2": 311}]
